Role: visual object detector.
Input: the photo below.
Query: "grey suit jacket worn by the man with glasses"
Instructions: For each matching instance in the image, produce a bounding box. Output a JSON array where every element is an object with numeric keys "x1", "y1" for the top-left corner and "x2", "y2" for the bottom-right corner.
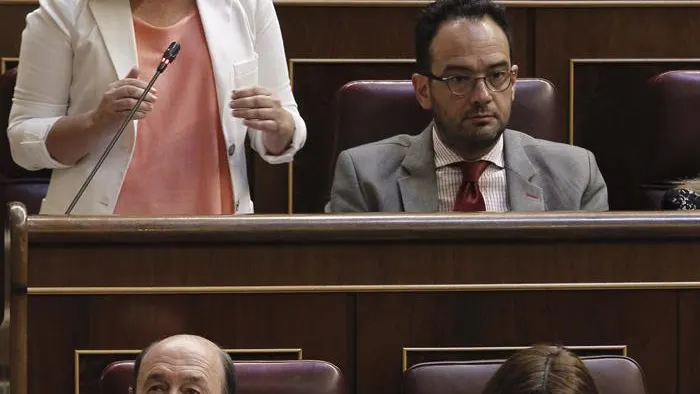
[{"x1": 326, "y1": 124, "x2": 608, "y2": 212}]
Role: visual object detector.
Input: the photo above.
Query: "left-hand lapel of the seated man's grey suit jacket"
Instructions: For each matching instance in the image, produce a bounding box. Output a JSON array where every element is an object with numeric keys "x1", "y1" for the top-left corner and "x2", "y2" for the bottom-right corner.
[{"x1": 398, "y1": 123, "x2": 438, "y2": 212}]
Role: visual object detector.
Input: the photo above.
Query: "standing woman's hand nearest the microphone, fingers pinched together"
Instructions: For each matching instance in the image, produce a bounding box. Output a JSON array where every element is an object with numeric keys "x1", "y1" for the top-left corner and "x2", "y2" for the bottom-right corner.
[{"x1": 92, "y1": 67, "x2": 158, "y2": 130}]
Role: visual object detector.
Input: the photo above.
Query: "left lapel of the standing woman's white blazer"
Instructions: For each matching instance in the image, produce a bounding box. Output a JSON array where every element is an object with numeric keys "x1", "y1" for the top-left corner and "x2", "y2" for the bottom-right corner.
[{"x1": 88, "y1": 0, "x2": 138, "y2": 79}]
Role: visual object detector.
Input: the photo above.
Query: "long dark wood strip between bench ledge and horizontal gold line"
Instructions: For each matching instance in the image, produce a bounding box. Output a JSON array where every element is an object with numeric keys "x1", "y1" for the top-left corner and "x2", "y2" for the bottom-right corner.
[{"x1": 24, "y1": 240, "x2": 700, "y2": 288}]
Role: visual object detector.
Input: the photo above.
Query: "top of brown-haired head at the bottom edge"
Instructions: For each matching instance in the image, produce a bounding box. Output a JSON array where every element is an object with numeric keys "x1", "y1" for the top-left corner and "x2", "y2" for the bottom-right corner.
[{"x1": 482, "y1": 345, "x2": 598, "y2": 394}]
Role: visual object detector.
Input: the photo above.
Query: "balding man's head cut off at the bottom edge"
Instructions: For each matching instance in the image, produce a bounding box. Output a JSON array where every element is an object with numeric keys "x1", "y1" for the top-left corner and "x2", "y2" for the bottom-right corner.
[{"x1": 129, "y1": 335, "x2": 236, "y2": 394}]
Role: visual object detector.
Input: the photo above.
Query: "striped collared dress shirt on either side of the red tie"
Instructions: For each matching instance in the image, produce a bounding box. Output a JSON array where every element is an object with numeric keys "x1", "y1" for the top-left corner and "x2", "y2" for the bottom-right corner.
[{"x1": 433, "y1": 127, "x2": 509, "y2": 212}]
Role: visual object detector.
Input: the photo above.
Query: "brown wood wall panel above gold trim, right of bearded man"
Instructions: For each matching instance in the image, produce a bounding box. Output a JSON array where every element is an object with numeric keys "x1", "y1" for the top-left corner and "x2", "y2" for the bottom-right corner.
[{"x1": 534, "y1": 7, "x2": 700, "y2": 140}]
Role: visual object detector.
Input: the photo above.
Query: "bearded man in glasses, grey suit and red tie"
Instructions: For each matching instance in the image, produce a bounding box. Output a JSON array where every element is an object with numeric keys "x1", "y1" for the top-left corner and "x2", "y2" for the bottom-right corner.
[{"x1": 327, "y1": 0, "x2": 608, "y2": 212}]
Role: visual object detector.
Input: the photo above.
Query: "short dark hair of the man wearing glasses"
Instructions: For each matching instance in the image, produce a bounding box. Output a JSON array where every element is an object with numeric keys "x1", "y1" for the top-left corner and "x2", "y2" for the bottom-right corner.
[{"x1": 415, "y1": 0, "x2": 513, "y2": 73}]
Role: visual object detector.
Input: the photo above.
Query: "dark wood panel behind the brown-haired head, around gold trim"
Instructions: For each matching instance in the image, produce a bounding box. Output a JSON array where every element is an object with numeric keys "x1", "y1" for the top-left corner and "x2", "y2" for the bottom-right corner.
[{"x1": 357, "y1": 291, "x2": 678, "y2": 394}]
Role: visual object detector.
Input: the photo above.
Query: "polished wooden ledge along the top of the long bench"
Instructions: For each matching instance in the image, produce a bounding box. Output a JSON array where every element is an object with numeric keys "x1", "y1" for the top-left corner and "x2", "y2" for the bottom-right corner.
[{"x1": 18, "y1": 211, "x2": 700, "y2": 244}]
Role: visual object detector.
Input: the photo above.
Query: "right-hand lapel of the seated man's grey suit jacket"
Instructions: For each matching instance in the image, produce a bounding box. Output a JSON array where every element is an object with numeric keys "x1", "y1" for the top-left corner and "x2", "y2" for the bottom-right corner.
[{"x1": 503, "y1": 130, "x2": 545, "y2": 211}]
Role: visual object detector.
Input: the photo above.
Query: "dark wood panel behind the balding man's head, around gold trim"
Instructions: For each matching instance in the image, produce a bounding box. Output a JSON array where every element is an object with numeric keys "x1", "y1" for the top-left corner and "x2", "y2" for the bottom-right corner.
[{"x1": 29, "y1": 294, "x2": 354, "y2": 394}]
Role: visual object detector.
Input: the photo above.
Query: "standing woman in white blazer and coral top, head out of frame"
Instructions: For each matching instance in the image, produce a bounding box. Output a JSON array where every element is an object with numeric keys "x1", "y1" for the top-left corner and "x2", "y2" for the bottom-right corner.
[{"x1": 8, "y1": 0, "x2": 306, "y2": 215}]
